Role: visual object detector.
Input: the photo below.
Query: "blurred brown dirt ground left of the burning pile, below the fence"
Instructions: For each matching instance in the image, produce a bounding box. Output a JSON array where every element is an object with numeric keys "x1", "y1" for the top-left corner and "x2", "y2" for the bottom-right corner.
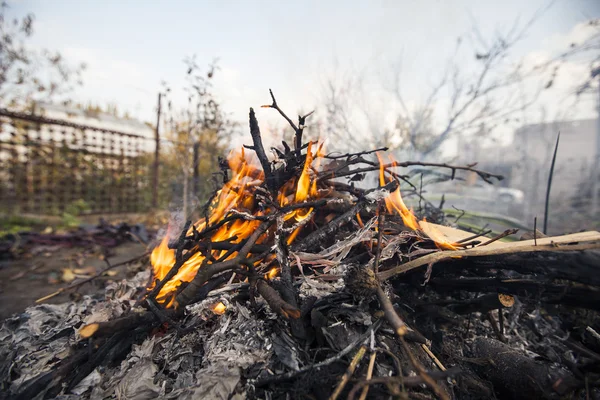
[{"x1": 0, "y1": 242, "x2": 147, "y2": 321}]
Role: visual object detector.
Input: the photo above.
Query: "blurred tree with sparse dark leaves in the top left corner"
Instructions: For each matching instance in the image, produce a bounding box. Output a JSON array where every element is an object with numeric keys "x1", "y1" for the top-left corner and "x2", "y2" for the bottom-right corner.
[{"x1": 0, "y1": 1, "x2": 85, "y2": 107}]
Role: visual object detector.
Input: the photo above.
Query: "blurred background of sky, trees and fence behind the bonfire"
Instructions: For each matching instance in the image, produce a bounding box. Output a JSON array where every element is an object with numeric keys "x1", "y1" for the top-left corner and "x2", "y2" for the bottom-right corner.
[{"x1": 0, "y1": 0, "x2": 600, "y2": 233}]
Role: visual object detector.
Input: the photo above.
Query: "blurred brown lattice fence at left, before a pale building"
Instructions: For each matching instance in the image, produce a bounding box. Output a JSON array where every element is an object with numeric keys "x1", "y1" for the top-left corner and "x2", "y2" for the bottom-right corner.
[{"x1": 0, "y1": 109, "x2": 157, "y2": 214}]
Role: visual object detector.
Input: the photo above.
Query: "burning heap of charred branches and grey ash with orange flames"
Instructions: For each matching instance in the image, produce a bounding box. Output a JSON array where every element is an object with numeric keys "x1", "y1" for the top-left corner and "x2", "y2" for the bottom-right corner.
[{"x1": 0, "y1": 93, "x2": 600, "y2": 399}]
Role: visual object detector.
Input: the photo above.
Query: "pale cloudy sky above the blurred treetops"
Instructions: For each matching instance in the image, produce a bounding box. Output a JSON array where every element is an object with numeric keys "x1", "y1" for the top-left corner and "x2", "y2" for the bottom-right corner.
[{"x1": 9, "y1": 0, "x2": 600, "y2": 153}]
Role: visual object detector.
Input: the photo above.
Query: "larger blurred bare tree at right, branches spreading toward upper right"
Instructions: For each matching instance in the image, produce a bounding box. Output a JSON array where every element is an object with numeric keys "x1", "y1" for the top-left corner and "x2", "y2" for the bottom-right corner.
[{"x1": 393, "y1": 10, "x2": 556, "y2": 157}]
